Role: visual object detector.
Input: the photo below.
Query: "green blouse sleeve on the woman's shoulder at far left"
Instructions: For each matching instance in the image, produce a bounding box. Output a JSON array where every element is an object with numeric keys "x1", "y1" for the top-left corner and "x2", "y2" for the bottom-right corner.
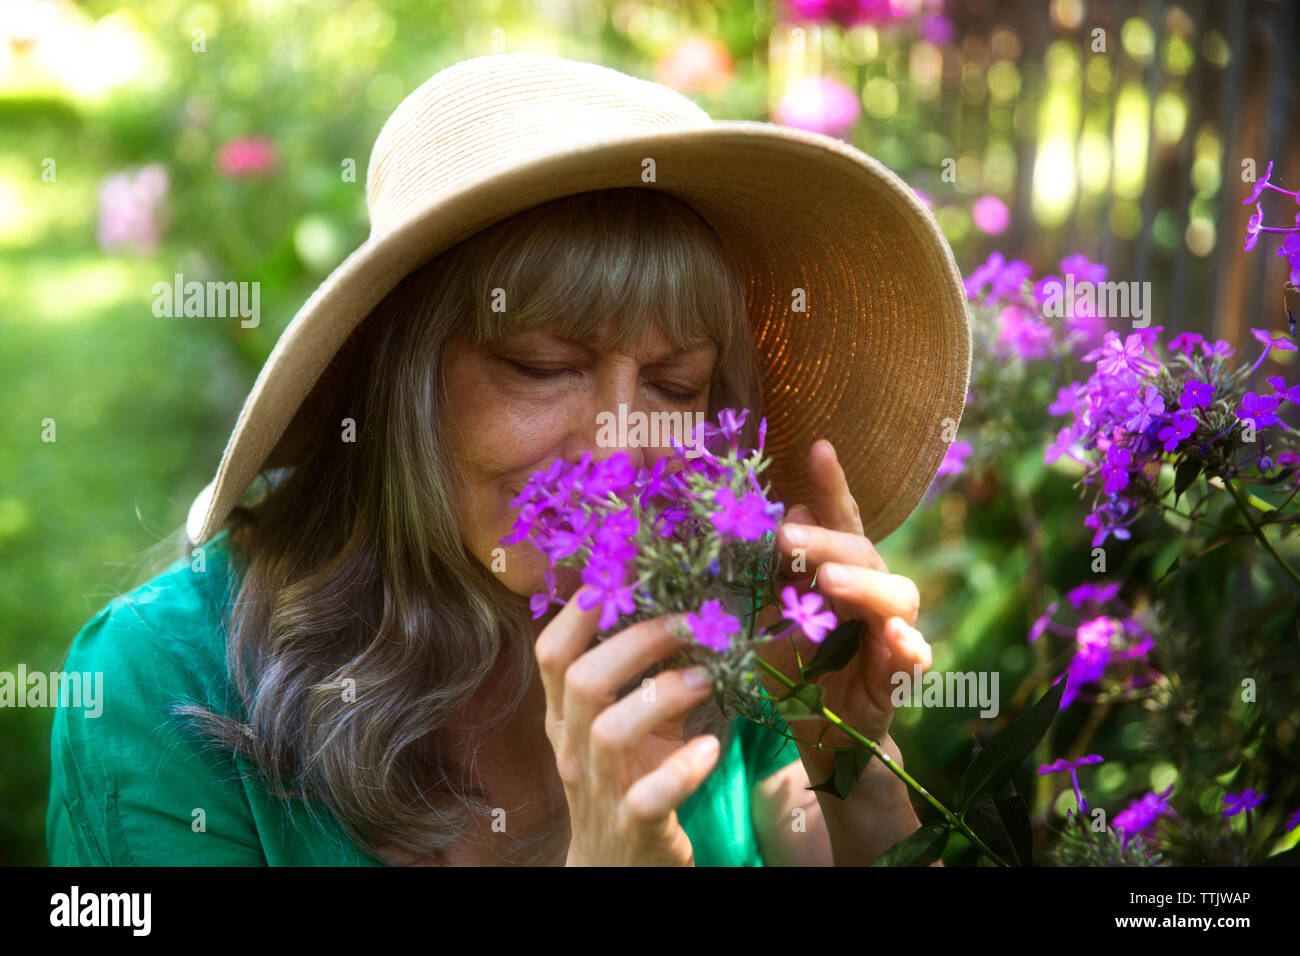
[{"x1": 46, "y1": 566, "x2": 267, "y2": 866}]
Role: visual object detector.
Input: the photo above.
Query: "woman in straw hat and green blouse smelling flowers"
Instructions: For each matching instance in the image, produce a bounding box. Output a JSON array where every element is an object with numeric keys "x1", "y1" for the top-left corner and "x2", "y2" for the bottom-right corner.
[{"x1": 47, "y1": 55, "x2": 970, "y2": 865}]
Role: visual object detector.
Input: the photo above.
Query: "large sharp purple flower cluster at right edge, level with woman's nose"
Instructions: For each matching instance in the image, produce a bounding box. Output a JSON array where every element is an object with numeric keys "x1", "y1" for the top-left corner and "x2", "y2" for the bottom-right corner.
[{"x1": 1044, "y1": 326, "x2": 1300, "y2": 548}]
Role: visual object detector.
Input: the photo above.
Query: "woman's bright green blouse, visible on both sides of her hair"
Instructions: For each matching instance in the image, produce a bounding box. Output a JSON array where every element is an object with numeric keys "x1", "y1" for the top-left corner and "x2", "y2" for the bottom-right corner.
[{"x1": 46, "y1": 533, "x2": 798, "y2": 866}]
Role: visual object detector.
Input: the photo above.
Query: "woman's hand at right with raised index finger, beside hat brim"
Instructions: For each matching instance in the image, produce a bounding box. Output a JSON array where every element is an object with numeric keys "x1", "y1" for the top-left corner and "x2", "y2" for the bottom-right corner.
[{"x1": 758, "y1": 438, "x2": 932, "y2": 782}]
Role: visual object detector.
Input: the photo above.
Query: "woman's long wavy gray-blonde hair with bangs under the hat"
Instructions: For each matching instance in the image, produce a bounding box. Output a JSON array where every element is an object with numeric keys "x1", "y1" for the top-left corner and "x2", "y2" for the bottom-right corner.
[{"x1": 174, "y1": 189, "x2": 762, "y2": 862}]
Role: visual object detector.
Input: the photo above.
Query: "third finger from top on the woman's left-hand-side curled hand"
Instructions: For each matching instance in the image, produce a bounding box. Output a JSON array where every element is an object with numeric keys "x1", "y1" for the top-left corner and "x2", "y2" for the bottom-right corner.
[{"x1": 590, "y1": 667, "x2": 712, "y2": 793}]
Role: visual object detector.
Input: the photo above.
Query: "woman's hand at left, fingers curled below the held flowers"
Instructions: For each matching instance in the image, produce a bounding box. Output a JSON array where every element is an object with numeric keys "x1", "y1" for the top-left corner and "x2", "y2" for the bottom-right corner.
[{"x1": 536, "y1": 591, "x2": 720, "y2": 866}]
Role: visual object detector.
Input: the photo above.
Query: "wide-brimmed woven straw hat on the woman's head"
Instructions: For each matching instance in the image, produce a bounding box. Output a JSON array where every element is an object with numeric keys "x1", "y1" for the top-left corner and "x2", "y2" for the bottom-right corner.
[{"x1": 186, "y1": 53, "x2": 970, "y2": 544}]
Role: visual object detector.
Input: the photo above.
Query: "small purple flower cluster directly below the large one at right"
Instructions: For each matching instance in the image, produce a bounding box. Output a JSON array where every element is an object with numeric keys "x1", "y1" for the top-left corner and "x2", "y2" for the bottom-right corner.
[{"x1": 1028, "y1": 583, "x2": 1160, "y2": 710}]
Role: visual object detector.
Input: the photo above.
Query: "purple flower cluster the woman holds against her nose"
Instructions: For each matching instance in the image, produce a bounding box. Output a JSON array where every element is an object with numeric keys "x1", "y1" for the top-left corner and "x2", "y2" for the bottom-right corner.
[{"x1": 501, "y1": 408, "x2": 836, "y2": 653}]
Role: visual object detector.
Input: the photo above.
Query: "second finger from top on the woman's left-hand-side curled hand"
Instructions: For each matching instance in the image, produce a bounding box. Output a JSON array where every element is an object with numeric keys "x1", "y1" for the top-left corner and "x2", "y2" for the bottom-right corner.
[{"x1": 562, "y1": 615, "x2": 683, "y2": 753}]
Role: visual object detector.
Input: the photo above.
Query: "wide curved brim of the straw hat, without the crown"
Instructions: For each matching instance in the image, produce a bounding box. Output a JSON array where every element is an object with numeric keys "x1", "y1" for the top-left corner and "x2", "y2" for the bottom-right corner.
[{"x1": 186, "y1": 121, "x2": 971, "y2": 544}]
